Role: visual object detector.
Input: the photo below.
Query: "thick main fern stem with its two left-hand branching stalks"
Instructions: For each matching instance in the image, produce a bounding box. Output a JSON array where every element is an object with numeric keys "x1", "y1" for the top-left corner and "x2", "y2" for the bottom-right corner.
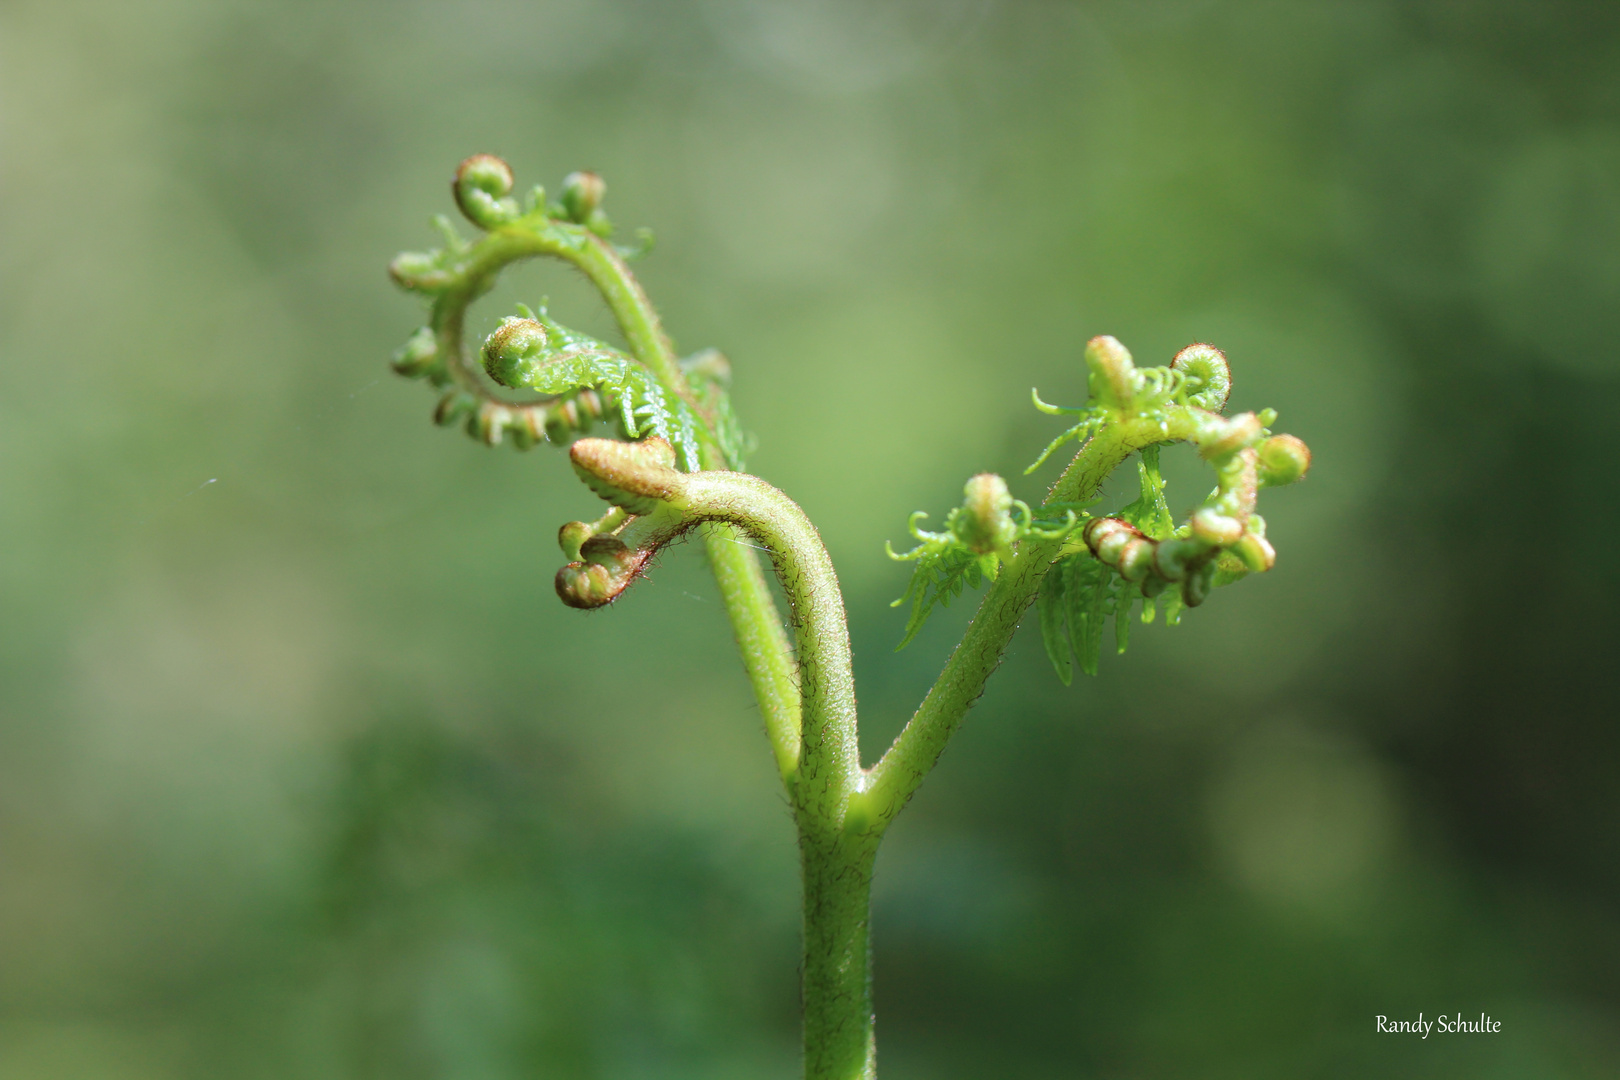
[{"x1": 544, "y1": 226, "x2": 876, "y2": 1080}]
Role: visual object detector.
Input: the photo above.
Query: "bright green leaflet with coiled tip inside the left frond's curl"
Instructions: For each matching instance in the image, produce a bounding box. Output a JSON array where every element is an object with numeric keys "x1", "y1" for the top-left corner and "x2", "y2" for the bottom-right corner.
[{"x1": 491, "y1": 308, "x2": 703, "y2": 473}]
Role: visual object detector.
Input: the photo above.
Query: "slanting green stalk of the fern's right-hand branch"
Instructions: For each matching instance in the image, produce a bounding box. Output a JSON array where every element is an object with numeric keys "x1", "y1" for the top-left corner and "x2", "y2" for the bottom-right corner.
[{"x1": 851, "y1": 406, "x2": 1197, "y2": 832}]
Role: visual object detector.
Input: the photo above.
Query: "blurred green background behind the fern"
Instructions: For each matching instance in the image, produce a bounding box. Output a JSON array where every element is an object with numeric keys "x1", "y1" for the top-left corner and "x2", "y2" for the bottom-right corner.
[{"x1": 0, "y1": 0, "x2": 1620, "y2": 1080}]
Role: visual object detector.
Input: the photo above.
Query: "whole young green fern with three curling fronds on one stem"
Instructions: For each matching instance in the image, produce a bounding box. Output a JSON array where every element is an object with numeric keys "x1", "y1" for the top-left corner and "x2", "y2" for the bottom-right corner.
[{"x1": 390, "y1": 154, "x2": 1311, "y2": 1077}]
